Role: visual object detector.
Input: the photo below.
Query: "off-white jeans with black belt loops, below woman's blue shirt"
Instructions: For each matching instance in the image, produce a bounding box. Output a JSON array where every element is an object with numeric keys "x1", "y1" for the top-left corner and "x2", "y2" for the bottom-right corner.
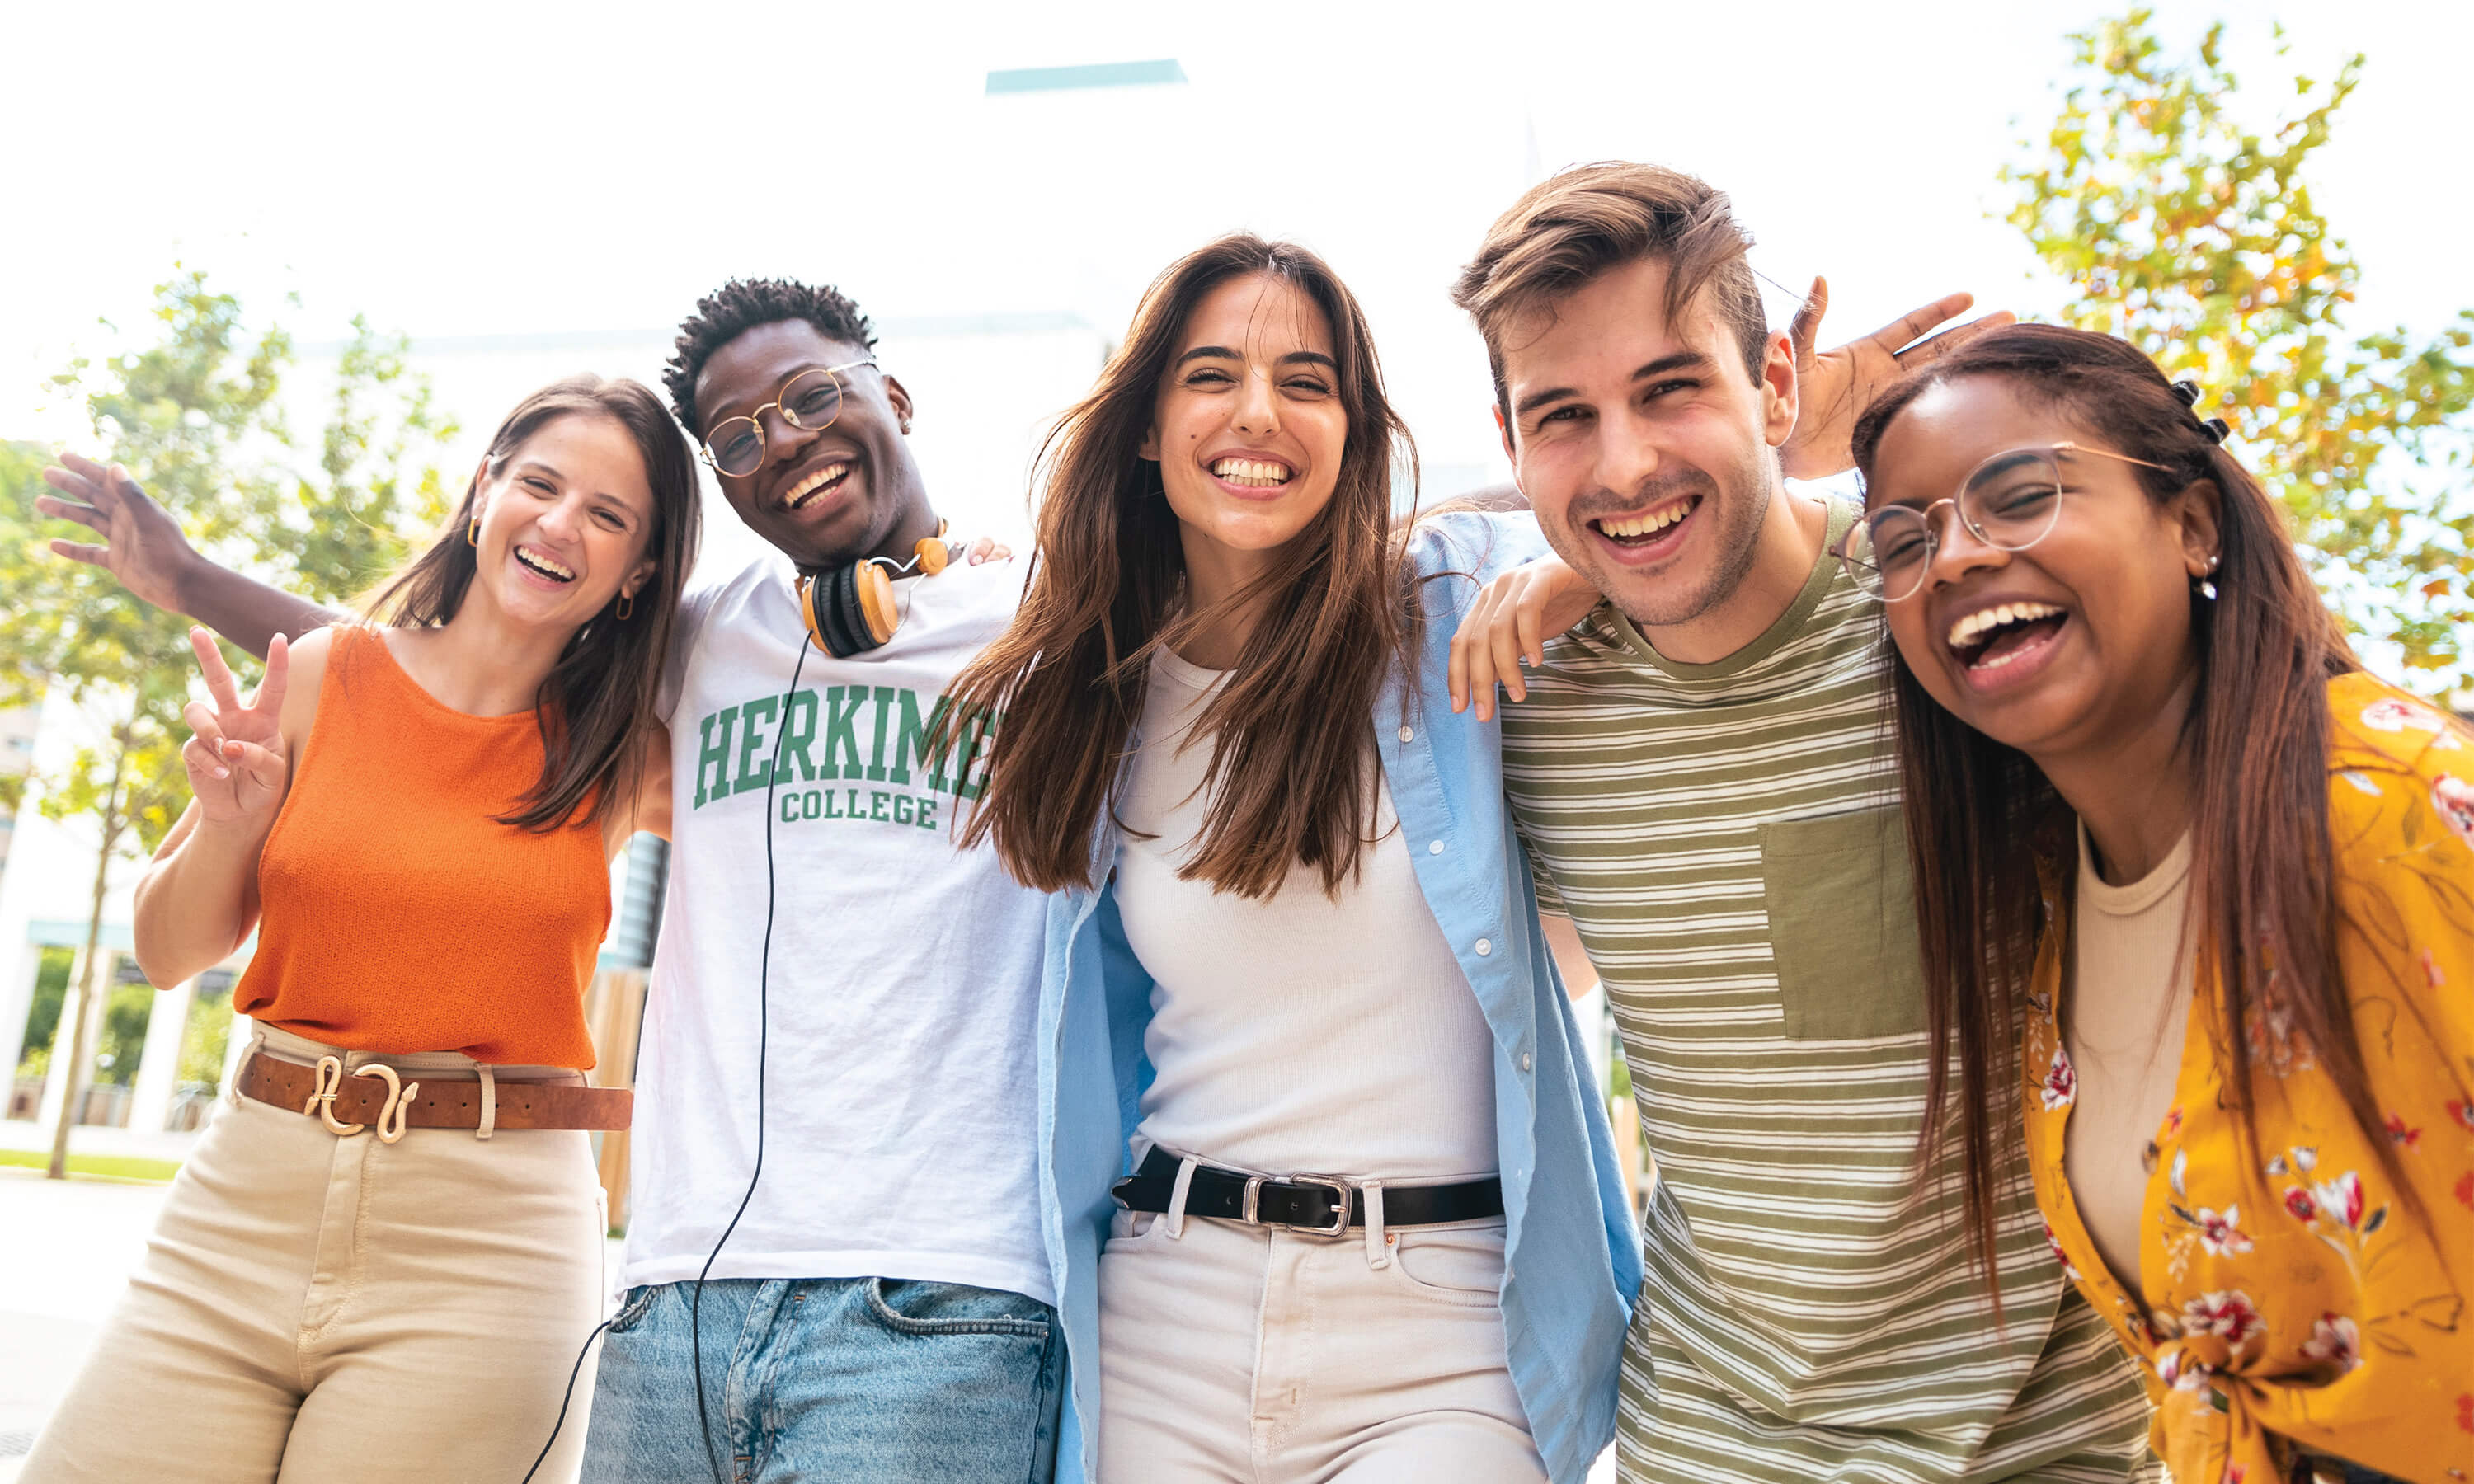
[{"x1": 1098, "y1": 1158, "x2": 1546, "y2": 1484}]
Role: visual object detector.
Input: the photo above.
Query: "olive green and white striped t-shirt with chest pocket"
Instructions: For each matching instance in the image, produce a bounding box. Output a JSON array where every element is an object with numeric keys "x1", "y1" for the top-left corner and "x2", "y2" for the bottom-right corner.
[{"x1": 1504, "y1": 502, "x2": 2152, "y2": 1484}]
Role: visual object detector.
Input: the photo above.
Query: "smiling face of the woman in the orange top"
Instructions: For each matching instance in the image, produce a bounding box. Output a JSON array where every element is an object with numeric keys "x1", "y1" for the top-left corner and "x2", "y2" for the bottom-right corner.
[{"x1": 473, "y1": 413, "x2": 653, "y2": 628}]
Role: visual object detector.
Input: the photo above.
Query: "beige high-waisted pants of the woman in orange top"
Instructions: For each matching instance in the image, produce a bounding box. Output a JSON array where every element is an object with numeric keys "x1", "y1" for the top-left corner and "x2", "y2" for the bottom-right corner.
[{"x1": 20, "y1": 1024, "x2": 606, "y2": 1484}]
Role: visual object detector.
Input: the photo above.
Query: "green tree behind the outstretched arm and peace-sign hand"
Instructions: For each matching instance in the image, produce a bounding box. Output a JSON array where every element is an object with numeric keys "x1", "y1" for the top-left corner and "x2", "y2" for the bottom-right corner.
[{"x1": 0, "y1": 270, "x2": 455, "y2": 1175}]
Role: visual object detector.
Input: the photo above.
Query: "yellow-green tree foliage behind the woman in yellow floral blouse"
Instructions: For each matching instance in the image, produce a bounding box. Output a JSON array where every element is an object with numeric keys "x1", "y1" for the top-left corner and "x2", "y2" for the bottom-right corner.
[{"x1": 2001, "y1": 10, "x2": 2474, "y2": 693}]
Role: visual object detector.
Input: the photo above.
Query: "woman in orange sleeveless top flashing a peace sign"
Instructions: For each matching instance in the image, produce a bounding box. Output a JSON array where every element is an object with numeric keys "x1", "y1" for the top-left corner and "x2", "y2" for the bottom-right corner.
[{"x1": 25, "y1": 376, "x2": 698, "y2": 1484}]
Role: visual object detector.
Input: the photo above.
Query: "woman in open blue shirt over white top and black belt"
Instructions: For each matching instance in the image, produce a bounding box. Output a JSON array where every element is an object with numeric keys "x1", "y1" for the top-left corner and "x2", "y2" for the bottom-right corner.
[{"x1": 957, "y1": 237, "x2": 1638, "y2": 1484}]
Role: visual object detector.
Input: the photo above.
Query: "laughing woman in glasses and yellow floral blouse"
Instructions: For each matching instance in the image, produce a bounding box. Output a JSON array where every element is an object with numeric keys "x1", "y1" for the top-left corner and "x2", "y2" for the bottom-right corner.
[{"x1": 1841, "y1": 326, "x2": 2474, "y2": 1484}]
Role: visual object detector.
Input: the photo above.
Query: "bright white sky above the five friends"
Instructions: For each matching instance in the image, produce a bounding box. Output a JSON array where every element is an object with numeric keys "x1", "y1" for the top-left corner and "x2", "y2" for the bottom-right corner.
[{"x1": 0, "y1": 0, "x2": 2474, "y2": 561}]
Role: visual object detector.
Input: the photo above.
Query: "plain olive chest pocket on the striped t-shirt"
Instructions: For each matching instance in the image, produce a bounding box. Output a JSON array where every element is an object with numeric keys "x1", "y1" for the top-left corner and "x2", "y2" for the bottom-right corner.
[{"x1": 1759, "y1": 809, "x2": 1925, "y2": 1041}]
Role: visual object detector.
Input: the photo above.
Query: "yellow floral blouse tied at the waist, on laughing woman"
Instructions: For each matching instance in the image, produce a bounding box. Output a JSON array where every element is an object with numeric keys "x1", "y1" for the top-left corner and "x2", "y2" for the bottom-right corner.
[{"x1": 2026, "y1": 675, "x2": 2474, "y2": 1484}]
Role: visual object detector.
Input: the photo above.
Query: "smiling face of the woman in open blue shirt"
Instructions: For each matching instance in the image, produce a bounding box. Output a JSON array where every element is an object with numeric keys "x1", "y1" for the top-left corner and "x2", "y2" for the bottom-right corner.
[{"x1": 1141, "y1": 275, "x2": 1348, "y2": 591}]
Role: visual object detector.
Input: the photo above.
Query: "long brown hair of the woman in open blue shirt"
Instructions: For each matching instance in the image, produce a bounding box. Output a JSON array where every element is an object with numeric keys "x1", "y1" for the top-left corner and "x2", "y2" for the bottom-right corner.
[{"x1": 948, "y1": 235, "x2": 1418, "y2": 898}]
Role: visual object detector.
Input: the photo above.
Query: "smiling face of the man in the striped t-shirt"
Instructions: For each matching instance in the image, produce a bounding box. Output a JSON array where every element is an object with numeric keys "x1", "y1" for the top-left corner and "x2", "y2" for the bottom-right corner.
[{"x1": 1497, "y1": 257, "x2": 1804, "y2": 628}]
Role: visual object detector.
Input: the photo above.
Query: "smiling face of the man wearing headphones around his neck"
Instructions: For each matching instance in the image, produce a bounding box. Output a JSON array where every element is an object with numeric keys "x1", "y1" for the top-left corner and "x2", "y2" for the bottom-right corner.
[{"x1": 695, "y1": 319, "x2": 935, "y2": 569}]
